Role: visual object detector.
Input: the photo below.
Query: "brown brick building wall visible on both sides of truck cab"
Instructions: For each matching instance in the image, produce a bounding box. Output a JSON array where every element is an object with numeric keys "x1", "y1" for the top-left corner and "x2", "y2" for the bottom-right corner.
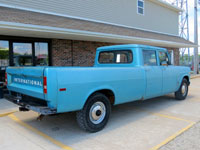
[{"x1": 52, "y1": 39, "x2": 179, "y2": 66}]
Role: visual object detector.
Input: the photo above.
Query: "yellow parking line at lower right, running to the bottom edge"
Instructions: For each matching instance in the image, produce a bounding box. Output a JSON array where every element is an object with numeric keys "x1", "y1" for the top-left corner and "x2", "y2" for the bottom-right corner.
[{"x1": 150, "y1": 122, "x2": 195, "y2": 150}]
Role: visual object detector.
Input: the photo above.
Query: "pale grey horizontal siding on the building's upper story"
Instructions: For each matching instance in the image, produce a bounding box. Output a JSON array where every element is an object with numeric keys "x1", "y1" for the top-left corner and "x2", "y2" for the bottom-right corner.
[{"x1": 0, "y1": 0, "x2": 179, "y2": 35}]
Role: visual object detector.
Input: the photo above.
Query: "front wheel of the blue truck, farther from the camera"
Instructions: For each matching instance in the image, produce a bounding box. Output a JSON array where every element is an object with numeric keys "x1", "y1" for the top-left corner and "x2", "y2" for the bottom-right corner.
[{"x1": 175, "y1": 78, "x2": 188, "y2": 100}]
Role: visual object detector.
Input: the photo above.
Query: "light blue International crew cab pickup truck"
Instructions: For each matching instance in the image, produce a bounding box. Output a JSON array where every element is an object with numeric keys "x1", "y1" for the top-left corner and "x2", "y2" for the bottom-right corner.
[{"x1": 6, "y1": 45, "x2": 190, "y2": 132}]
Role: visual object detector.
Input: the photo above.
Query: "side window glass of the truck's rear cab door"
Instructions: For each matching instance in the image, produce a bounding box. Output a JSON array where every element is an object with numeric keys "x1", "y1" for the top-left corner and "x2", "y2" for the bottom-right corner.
[{"x1": 143, "y1": 50, "x2": 157, "y2": 66}]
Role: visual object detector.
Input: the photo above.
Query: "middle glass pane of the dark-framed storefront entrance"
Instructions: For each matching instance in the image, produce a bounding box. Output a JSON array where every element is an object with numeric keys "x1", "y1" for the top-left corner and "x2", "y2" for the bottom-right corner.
[{"x1": 13, "y1": 42, "x2": 34, "y2": 66}]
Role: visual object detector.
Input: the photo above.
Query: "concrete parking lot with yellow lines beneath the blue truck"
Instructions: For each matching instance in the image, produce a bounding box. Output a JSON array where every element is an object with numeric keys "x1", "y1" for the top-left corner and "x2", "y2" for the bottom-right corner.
[{"x1": 0, "y1": 78, "x2": 200, "y2": 150}]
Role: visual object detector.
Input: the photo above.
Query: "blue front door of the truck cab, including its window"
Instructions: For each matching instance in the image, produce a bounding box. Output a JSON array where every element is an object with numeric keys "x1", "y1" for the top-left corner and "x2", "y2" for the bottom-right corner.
[{"x1": 158, "y1": 51, "x2": 178, "y2": 94}]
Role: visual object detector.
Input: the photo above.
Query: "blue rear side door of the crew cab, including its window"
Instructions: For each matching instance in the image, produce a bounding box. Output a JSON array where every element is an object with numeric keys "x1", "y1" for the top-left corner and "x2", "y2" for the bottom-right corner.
[{"x1": 143, "y1": 50, "x2": 162, "y2": 98}]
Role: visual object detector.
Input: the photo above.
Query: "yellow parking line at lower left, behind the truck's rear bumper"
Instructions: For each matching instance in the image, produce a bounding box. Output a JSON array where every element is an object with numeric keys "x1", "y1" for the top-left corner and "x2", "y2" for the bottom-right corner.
[{"x1": 8, "y1": 114, "x2": 72, "y2": 150}]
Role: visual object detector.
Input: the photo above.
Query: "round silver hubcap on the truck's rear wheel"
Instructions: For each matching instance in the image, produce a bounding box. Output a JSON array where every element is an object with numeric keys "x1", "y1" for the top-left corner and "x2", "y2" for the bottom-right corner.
[{"x1": 89, "y1": 102, "x2": 106, "y2": 124}]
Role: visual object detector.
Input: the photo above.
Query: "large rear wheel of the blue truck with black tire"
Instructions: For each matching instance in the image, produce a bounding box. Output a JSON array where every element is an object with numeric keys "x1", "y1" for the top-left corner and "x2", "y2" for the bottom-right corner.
[{"x1": 76, "y1": 93, "x2": 111, "y2": 133}]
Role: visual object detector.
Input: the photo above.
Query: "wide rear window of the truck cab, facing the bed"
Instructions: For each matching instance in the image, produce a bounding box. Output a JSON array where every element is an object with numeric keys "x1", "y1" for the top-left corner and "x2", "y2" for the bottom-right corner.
[{"x1": 98, "y1": 50, "x2": 133, "y2": 64}]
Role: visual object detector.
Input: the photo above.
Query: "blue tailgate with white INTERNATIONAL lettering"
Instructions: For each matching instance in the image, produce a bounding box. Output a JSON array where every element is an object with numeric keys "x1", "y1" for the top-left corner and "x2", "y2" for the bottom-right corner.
[{"x1": 6, "y1": 67, "x2": 45, "y2": 99}]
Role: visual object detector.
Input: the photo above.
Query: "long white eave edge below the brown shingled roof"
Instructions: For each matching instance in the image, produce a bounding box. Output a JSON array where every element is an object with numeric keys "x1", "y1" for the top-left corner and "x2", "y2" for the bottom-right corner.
[{"x1": 0, "y1": 21, "x2": 197, "y2": 48}]
